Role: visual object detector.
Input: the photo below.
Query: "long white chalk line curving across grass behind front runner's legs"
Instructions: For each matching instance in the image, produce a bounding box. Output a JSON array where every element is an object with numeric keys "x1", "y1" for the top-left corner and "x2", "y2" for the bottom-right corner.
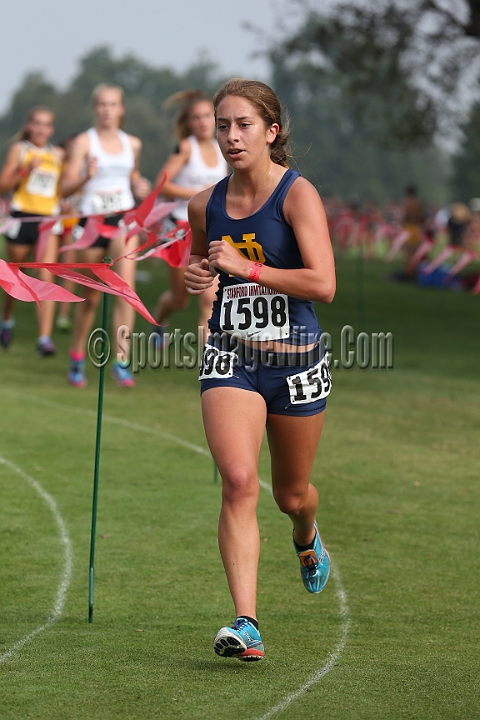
[{"x1": 0, "y1": 389, "x2": 350, "y2": 720}]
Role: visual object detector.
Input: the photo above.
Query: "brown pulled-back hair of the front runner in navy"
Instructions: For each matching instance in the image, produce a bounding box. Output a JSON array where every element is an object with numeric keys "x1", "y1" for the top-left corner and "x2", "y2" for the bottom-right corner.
[{"x1": 213, "y1": 78, "x2": 291, "y2": 167}]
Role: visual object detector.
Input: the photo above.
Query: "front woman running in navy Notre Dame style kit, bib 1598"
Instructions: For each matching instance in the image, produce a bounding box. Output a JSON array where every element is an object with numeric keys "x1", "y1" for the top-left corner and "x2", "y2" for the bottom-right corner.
[{"x1": 185, "y1": 79, "x2": 335, "y2": 661}]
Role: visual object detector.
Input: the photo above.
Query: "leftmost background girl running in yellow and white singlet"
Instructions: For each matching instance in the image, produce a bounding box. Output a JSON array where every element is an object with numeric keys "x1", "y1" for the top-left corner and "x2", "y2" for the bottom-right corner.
[{"x1": 0, "y1": 107, "x2": 64, "y2": 357}]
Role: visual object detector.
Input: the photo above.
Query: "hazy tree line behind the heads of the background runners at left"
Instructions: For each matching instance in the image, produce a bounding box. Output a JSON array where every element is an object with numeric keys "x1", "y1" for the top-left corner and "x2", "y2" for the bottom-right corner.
[{"x1": 0, "y1": 47, "x2": 225, "y2": 180}]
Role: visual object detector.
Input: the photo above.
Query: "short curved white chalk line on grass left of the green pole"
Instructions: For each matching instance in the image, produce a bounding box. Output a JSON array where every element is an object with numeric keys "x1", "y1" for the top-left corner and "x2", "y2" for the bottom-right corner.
[{"x1": 0, "y1": 455, "x2": 72, "y2": 665}]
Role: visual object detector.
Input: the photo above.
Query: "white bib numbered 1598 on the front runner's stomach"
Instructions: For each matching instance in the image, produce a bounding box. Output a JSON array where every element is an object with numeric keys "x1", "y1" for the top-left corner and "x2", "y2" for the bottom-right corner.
[{"x1": 220, "y1": 283, "x2": 290, "y2": 340}]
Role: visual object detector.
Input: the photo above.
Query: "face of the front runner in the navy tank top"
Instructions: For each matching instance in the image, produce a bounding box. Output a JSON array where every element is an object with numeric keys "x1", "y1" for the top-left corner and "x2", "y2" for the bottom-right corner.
[{"x1": 217, "y1": 95, "x2": 279, "y2": 170}]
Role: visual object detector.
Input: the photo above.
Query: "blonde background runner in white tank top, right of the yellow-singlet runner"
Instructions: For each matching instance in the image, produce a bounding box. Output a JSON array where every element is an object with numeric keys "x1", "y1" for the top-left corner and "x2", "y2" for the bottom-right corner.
[{"x1": 62, "y1": 84, "x2": 150, "y2": 388}]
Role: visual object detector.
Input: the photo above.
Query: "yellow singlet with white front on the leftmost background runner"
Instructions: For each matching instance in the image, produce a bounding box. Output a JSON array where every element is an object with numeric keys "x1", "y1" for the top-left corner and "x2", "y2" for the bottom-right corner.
[{"x1": 11, "y1": 140, "x2": 62, "y2": 215}]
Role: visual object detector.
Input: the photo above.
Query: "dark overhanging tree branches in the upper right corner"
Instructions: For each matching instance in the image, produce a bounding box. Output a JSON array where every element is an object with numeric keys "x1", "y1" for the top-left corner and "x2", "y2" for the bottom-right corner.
[{"x1": 270, "y1": 0, "x2": 480, "y2": 149}]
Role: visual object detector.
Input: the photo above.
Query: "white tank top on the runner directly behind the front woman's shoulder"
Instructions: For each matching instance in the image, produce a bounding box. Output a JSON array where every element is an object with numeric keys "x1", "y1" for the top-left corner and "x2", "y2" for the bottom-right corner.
[{"x1": 172, "y1": 135, "x2": 228, "y2": 220}]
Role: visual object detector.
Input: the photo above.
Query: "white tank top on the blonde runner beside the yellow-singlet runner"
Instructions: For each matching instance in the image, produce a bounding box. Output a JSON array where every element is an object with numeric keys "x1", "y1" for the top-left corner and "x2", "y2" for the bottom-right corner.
[{"x1": 79, "y1": 128, "x2": 135, "y2": 215}]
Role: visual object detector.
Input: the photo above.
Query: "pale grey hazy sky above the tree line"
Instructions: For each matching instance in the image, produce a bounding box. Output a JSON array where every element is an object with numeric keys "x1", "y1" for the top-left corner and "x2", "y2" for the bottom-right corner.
[{"x1": 0, "y1": 0, "x2": 291, "y2": 112}]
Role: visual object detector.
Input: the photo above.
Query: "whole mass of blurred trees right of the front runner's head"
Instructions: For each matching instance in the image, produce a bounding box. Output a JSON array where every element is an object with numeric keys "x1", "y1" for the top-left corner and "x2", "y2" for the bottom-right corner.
[{"x1": 268, "y1": 0, "x2": 480, "y2": 200}]
